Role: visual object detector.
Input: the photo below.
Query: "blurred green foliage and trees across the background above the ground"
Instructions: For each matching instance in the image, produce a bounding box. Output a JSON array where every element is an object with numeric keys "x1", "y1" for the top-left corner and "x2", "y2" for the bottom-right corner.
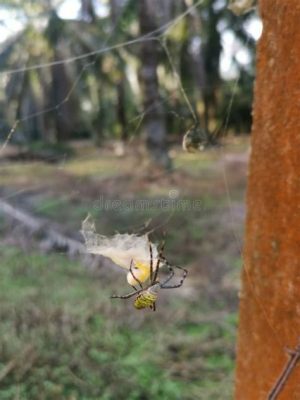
[{"x1": 0, "y1": 0, "x2": 255, "y2": 148}]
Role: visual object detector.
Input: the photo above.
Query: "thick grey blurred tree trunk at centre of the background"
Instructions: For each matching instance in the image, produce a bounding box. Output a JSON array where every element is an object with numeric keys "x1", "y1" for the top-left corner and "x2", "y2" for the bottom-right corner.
[{"x1": 139, "y1": 0, "x2": 170, "y2": 168}]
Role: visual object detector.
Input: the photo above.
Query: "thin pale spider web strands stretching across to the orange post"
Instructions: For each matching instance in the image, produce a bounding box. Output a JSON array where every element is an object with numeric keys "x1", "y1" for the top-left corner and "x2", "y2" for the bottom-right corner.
[{"x1": 0, "y1": 0, "x2": 284, "y2": 360}]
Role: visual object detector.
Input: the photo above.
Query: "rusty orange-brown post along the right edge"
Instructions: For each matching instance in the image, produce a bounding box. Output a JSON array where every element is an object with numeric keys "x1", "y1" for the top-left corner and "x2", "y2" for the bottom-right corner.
[{"x1": 235, "y1": 0, "x2": 300, "y2": 400}]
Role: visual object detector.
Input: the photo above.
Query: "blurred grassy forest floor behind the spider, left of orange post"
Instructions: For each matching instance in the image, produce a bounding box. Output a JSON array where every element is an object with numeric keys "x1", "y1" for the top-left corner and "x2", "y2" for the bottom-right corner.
[{"x1": 0, "y1": 138, "x2": 249, "y2": 400}]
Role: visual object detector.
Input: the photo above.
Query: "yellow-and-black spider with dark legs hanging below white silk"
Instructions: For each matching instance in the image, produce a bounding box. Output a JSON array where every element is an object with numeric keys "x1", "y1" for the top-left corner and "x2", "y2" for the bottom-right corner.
[{"x1": 111, "y1": 243, "x2": 188, "y2": 311}]
